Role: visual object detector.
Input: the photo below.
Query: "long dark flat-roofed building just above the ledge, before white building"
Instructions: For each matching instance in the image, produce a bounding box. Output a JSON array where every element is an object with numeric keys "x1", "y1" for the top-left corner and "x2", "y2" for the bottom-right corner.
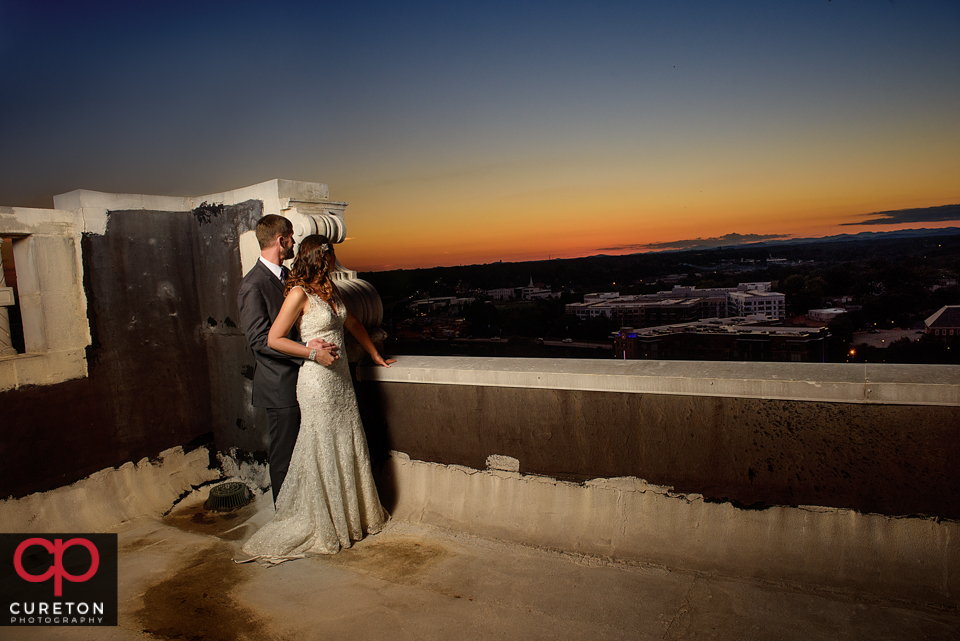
[{"x1": 613, "y1": 318, "x2": 827, "y2": 363}]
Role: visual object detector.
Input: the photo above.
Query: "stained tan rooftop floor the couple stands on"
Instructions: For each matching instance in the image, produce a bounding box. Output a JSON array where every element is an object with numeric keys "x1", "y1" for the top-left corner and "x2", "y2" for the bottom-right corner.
[{"x1": 9, "y1": 490, "x2": 960, "y2": 641}]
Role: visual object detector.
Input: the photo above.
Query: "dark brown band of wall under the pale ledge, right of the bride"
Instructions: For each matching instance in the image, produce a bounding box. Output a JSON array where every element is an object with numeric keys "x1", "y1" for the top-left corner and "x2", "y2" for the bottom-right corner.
[{"x1": 362, "y1": 383, "x2": 960, "y2": 519}]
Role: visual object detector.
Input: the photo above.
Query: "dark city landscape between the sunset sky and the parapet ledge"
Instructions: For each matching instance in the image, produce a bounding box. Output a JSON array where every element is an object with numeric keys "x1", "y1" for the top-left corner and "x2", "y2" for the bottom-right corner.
[{"x1": 363, "y1": 229, "x2": 960, "y2": 363}]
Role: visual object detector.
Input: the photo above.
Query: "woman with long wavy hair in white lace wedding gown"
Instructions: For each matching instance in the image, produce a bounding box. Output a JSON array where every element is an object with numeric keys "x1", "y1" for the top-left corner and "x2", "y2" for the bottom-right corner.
[{"x1": 243, "y1": 235, "x2": 396, "y2": 562}]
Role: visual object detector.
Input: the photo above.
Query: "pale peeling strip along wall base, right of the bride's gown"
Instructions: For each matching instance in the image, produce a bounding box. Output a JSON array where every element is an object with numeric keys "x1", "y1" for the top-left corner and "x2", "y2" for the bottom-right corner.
[{"x1": 386, "y1": 453, "x2": 960, "y2": 607}]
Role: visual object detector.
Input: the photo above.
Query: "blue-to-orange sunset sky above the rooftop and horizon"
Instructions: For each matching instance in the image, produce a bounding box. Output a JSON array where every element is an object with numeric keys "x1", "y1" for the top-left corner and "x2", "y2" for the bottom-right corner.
[{"x1": 0, "y1": 0, "x2": 960, "y2": 271}]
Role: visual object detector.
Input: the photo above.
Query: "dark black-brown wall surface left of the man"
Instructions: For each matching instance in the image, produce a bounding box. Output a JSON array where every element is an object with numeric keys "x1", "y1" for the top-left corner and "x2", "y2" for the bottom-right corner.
[{"x1": 0, "y1": 202, "x2": 262, "y2": 497}]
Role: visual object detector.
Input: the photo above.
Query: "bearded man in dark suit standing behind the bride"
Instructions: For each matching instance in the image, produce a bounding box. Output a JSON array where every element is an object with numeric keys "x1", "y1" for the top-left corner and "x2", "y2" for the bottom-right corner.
[{"x1": 237, "y1": 214, "x2": 338, "y2": 504}]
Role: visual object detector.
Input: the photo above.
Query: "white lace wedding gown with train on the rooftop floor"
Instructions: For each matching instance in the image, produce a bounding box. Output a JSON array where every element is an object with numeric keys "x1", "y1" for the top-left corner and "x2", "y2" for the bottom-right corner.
[{"x1": 243, "y1": 286, "x2": 385, "y2": 561}]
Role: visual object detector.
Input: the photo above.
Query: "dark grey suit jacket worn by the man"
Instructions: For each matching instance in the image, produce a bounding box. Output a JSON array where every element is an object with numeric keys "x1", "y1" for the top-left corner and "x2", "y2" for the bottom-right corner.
[{"x1": 237, "y1": 259, "x2": 303, "y2": 407}]
